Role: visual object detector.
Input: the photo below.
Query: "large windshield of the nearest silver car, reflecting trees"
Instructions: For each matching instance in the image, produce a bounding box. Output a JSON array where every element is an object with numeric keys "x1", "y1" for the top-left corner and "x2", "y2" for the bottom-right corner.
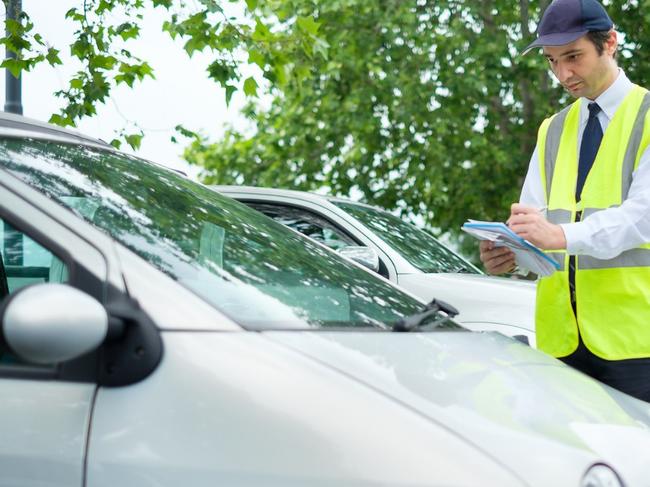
[{"x1": 0, "y1": 139, "x2": 442, "y2": 329}]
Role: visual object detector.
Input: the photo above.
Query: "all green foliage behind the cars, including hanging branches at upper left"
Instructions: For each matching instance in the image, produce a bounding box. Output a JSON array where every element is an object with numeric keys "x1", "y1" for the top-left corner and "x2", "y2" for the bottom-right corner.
[{"x1": 0, "y1": 0, "x2": 650, "y2": 262}]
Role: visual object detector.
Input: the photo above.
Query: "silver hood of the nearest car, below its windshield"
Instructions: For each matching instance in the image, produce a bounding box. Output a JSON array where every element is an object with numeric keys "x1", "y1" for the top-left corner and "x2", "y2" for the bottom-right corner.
[{"x1": 265, "y1": 331, "x2": 650, "y2": 486}]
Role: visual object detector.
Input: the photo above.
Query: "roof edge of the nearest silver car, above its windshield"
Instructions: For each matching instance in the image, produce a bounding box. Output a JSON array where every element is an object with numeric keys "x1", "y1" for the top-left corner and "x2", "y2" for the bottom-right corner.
[{"x1": 0, "y1": 112, "x2": 113, "y2": 149}]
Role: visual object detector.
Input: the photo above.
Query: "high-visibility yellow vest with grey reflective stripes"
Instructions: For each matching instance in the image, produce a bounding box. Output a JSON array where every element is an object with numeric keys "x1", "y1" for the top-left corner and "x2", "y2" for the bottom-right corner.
[{"x1": 535, "y1": 85, "x2": 650, "y2": 360}]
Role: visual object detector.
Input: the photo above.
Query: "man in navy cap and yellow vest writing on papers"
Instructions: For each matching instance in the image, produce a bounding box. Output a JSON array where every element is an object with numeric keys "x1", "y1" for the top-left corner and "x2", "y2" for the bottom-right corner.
[{"x1": 480, "y1": 0, "x2": 650, "y2": 401}]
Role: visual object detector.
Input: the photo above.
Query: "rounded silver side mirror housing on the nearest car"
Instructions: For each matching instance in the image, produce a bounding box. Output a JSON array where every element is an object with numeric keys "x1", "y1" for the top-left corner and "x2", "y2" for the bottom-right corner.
[{"x1": 0, "y1": 283, "x2": 108, "y2": 365}]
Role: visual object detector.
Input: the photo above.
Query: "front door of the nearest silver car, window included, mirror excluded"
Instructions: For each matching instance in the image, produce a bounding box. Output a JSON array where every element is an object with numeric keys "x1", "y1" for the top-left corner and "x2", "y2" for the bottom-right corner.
[{"x1": 0, "y1": 180, "x2": 113, "y2": 487}]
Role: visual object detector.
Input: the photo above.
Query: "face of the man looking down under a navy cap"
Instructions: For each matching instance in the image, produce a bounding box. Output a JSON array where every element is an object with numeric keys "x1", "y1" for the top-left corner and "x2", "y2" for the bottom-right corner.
[{"x1": 544, "y1": 32, "x2": 617, "y2": 100}]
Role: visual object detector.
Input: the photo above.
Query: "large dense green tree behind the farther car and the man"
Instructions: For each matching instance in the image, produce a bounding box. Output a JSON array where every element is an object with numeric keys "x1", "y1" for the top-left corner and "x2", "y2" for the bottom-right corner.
[{"x1": 185, "y1": 0, "x2": 650, "y2": 258}]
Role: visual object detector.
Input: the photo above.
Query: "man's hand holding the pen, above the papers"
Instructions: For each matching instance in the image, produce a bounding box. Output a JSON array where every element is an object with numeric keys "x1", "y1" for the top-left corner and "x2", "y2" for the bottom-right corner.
[{"x1": 508, "y1": 203, "x2": 566, "y2": 250}]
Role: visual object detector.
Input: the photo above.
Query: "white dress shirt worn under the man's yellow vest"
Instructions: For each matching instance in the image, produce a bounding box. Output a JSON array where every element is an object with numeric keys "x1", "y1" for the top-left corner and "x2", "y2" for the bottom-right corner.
[{"x1": 520, "y1": 69, "x2": 650, "y2": 259}]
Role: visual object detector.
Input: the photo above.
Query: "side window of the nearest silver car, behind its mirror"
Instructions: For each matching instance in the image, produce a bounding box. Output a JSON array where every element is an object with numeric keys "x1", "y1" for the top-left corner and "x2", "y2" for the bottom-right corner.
[{"x1": 0, "y1": 218, "x2": 68, "y2": 366}]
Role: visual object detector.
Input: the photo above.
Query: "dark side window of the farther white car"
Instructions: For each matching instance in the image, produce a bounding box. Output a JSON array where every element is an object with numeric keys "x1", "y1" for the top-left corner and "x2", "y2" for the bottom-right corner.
[{"x1": 246, "y1": 201, "x2": 358, "y2": 250}]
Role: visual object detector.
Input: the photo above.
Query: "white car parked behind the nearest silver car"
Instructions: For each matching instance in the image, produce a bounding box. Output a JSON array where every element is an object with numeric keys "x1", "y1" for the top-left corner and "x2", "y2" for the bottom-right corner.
[{"x1": 211, "y1": 186, "x2": 535, "y2": 345}]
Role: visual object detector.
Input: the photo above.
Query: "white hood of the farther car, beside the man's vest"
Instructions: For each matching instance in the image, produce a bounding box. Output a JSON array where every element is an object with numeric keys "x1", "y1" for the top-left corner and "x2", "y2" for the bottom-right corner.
[{"x1": 398, "y1": 274, "x2": 536, "y2": 334}]
